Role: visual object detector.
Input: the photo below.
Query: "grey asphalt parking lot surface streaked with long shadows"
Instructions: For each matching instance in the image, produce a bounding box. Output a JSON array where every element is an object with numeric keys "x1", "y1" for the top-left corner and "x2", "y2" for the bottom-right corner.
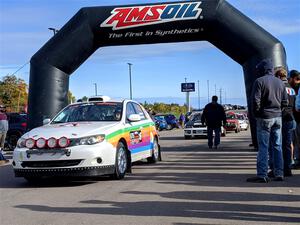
[{"x1": 0, "y1": 129, "x2": 300, "y2": 225}]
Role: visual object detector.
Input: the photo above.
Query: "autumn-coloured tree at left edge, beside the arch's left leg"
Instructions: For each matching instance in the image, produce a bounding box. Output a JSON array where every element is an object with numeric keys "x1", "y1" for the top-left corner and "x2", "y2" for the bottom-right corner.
[{"x1": 0, "y1": 75, "x2": 28, "y2": 112}]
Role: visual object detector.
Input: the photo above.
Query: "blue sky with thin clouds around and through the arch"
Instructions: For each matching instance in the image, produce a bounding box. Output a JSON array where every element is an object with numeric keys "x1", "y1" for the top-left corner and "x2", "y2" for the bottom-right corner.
[{"x1": 0, "y1": 0, "x2": 300, "y2": 107}]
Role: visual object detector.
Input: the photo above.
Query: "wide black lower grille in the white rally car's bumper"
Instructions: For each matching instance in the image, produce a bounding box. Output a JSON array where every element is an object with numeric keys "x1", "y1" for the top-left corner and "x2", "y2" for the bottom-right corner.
[{"x1": 21, "y1": 159, "x2": 82, "y2": 168}]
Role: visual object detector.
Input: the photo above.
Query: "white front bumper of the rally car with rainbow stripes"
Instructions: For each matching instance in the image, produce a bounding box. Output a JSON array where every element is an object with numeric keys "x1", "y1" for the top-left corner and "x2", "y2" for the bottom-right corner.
[{"x1": 13, "y1": 142, "x2": 116, "y2": 177}]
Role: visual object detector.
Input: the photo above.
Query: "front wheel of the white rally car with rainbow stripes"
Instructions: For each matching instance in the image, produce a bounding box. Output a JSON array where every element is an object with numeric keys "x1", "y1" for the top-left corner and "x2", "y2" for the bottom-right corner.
[{"x1": 113, "y1": 142, "x2": 128, "y2": 180}]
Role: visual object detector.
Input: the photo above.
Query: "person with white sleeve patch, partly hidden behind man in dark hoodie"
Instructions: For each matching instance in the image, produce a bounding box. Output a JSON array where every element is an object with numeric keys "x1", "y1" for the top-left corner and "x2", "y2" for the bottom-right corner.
[{"x1": 268, "y1": 67, "x2": 296, "y2": 177}]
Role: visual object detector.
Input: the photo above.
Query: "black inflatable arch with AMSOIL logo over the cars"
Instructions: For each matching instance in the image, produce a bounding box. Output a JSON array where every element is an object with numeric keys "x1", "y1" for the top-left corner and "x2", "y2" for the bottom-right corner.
[{"x1": 28, "y1": 0, "x2": 286, "y2": 146}]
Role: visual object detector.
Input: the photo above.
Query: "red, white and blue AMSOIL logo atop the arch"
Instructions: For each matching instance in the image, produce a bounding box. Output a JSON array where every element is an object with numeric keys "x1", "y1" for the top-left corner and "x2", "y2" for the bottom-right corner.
[{"x1": 100, "y1": 2, "x2": 202, "y2": 30}]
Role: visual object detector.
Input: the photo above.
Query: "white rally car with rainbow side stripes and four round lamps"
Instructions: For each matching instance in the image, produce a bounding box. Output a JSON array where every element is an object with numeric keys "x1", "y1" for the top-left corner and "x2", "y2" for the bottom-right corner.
[{"x1": 13, "y1": 96, "x2": 160, "y2": 180}]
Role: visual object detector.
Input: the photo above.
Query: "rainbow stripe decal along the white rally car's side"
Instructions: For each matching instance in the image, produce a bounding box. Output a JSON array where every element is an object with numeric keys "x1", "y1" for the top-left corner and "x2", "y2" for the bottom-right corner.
[{"x1": 105, "y1": 122, "x2": 157, "y2": 154}]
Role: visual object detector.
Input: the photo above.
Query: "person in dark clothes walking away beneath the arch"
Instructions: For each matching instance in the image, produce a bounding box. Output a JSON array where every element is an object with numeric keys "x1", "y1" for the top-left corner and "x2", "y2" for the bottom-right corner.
[{"x1": 201, "y1": 96, "x2": 226, "y2": 149}]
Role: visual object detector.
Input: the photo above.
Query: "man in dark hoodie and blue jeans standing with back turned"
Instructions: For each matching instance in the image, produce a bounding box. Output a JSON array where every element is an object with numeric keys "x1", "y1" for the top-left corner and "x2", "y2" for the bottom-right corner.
[{"x1": 247, "y1": 59, "x2": 288, "y2": 183}]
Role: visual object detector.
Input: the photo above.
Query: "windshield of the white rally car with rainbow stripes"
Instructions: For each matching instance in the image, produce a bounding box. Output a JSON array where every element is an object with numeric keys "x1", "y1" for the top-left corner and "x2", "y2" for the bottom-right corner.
[{"x1": 52, "y1": 102, "x2": 122, "y2": 124}]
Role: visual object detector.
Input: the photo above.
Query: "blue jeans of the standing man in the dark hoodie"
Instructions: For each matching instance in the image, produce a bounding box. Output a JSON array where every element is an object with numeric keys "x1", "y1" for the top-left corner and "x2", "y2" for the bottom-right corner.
[{"x1": 256, "y1": 117, "x2": 283, "y2": 178}]
